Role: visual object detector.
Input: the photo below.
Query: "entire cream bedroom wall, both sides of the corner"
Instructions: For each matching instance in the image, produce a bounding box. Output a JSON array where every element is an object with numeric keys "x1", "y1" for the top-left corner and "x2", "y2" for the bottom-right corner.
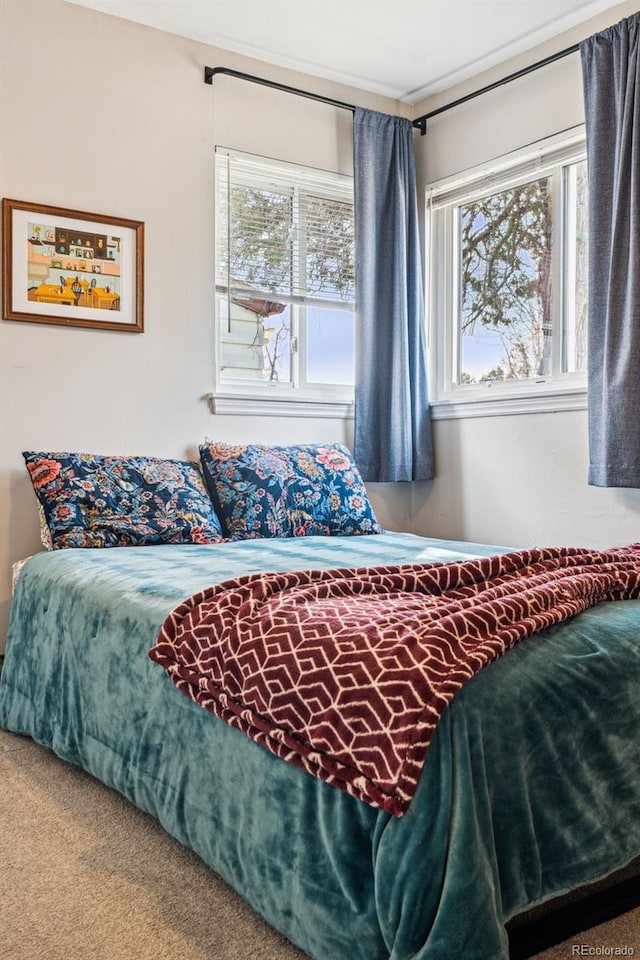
[{"x1": 0, "y1": 0, "x2": 640, "y2": 648}]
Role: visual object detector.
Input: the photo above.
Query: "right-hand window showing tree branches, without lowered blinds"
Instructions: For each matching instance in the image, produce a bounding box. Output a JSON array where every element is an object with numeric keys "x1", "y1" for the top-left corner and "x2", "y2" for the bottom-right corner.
[{"x1": 427, "y1": 130, "x2": 588, "y2": 415}]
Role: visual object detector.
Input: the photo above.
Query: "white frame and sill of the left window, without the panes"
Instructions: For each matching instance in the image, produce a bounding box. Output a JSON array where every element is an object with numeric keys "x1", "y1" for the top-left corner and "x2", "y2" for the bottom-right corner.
[{"x1": 214, "y1": 146, "x2": 355, "y2": 418}]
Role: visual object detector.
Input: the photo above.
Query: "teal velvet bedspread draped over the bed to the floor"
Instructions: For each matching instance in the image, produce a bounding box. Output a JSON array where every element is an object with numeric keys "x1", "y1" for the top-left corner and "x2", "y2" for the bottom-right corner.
[{"x1": 0, "y1": 533, "x2": 640, "y2": 960}]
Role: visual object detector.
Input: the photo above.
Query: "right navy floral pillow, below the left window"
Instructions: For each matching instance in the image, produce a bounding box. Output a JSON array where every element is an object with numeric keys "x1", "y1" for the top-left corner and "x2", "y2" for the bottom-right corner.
[{"x1": 200, "y1": 441, "x2": 382, "y2": 540}]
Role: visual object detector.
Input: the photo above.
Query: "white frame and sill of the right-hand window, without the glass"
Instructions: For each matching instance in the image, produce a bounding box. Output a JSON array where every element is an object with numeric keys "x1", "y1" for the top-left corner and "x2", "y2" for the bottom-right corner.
[{"x1": 425, "y1": 124, "x2": 586, "y2": 419}]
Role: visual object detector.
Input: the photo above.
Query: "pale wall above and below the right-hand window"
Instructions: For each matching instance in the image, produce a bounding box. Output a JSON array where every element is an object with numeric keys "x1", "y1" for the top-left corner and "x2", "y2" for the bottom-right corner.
[{"x1": 412, "y1": 2, "x2": 640, "y2": 547}]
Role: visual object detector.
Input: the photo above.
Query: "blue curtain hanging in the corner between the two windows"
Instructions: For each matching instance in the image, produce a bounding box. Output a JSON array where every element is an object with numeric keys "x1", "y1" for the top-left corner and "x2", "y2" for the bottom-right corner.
[{"x1": 354, "y1": 108, "x2": 433, "y2": 481}]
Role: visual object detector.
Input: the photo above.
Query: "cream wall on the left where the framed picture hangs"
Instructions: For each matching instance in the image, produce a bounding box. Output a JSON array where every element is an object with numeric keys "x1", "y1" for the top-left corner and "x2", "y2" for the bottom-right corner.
[{"x1": 0, "y1": 0, "x2": 410, "y2": 649}]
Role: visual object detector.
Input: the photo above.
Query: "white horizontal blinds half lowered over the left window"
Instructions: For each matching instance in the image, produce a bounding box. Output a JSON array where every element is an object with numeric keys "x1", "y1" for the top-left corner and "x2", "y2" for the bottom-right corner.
[{"x1": 216, "y1": 149, "x2": 354, "y2": 308}]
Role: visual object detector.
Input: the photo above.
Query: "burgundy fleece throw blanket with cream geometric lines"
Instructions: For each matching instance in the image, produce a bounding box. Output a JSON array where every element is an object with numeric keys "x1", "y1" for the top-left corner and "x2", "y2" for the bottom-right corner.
[{"x1": 149, "y1": 543, "x2": 640, "y2": 816}]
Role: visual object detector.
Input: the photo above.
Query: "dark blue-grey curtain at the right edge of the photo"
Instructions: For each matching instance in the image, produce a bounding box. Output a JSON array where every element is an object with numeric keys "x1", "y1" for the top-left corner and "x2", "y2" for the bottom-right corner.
[{"x1": 580, "y1": 13, "x2": 640, "y2": 487}]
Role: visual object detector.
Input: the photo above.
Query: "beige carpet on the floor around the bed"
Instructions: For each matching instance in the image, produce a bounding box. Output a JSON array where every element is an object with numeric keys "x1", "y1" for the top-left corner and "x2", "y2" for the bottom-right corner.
[{"x1": 0, "y1": 731, "x2": 640, "y2": 960}]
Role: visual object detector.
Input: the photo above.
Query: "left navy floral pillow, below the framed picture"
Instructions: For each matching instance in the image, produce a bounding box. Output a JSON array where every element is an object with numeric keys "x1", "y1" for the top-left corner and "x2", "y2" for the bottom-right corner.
[{"x1": 23, "y1": 451, "x2": 223, "y2": 550}]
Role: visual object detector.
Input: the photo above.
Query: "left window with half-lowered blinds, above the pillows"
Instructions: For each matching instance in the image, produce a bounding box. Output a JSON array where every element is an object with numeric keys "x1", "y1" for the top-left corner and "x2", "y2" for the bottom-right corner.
[{"x1": 216, "y1": 149, "x2": 355, "y2": 412}]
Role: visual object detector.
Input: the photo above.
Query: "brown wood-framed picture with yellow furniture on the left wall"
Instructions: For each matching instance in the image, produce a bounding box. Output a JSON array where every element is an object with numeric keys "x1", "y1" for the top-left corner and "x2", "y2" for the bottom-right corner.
[{"x1": 2, "y1": 198, "x2": 144, "y2": 333}]
